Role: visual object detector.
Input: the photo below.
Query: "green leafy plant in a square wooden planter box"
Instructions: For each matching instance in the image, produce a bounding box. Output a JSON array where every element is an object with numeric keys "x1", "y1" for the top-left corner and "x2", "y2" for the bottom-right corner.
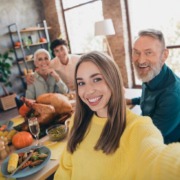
[{"x1": 0, "y1": 50, "x2": 16, "y2": 110}]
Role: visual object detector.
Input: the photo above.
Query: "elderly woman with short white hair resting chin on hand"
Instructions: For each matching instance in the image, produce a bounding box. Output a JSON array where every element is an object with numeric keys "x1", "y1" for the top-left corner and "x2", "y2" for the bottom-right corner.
[{"x1": 26, "y1": 49, "x2": 68, "y2": 99}]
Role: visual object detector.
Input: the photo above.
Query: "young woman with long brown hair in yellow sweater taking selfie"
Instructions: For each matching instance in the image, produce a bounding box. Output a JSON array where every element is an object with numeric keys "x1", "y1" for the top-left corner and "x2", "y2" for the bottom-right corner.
[{"x1": 55, "y1": 52, "x2": 180, "y2": 180}]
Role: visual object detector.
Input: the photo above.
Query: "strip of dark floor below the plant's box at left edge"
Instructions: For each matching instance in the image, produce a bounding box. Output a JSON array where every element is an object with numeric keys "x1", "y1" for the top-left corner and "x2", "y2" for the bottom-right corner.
[{"x1": 0, "y1": 108, "x2": 18, "y2": 122}]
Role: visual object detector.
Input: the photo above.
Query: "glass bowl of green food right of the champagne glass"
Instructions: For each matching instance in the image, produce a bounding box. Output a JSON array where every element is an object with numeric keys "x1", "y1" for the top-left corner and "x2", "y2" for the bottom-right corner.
[{"x1": 46, "y1": 124, "x2": 68, "y2": 141}]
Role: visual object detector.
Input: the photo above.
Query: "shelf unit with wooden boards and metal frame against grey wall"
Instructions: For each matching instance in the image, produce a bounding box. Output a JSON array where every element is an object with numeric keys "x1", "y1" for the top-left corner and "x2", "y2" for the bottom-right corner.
[{"x1": 8, "y1": 20, "x2": 51, "y2": 89}]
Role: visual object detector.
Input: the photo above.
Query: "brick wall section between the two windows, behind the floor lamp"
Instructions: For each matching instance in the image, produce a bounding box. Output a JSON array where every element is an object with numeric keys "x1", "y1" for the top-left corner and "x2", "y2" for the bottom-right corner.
[{"x1": 102, "y1": 0, "x2": 132, "y2": 87}]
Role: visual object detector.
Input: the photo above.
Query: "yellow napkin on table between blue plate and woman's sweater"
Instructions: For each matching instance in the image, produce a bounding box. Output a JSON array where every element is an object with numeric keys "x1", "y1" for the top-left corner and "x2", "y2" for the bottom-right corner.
[{"x1": 44, "y1": 140, "x2": 67, "y2": 160}]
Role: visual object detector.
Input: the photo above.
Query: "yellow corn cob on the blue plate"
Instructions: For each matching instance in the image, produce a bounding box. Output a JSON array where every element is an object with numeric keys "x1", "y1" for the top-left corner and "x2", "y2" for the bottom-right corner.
[{"x1": 7, "y1": 153, "x2": 19, "y2": 173}]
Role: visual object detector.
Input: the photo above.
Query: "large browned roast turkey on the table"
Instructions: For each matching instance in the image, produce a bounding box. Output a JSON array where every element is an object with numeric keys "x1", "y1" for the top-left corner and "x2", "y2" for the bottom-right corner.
[{"x1": 23, "y1": 93, "x2": 73, "y2": 124}]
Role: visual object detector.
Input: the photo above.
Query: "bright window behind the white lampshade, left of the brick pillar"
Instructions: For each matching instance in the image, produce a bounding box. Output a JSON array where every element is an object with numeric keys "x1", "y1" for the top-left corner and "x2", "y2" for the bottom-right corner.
[{"x1": 62, "y1": 0, "x2": 103, "y2": 54}]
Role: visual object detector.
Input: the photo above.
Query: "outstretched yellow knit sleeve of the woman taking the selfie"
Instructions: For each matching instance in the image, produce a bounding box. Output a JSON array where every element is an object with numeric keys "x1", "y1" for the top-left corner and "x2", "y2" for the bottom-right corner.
[{"x1": 126, "y1": 118, "x2": 180, "y2": 180}]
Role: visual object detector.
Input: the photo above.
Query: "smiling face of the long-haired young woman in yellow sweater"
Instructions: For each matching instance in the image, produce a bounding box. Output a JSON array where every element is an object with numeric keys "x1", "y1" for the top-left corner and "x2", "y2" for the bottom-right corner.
[{"x1": 76, "y1": 62, "x2": 111, "y2": 117}]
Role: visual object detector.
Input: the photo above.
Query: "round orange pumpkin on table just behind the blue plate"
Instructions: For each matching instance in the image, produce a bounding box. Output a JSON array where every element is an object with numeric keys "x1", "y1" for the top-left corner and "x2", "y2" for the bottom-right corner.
[{"x1": 12, "y1": 131, "x2": 33, "y2": 149}]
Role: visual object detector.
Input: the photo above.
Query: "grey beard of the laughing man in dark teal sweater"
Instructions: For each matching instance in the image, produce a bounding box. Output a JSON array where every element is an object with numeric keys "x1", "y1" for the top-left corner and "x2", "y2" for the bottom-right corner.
[{"x1": 133, "y1": 61, "x2": 162, "y2": 82}]
